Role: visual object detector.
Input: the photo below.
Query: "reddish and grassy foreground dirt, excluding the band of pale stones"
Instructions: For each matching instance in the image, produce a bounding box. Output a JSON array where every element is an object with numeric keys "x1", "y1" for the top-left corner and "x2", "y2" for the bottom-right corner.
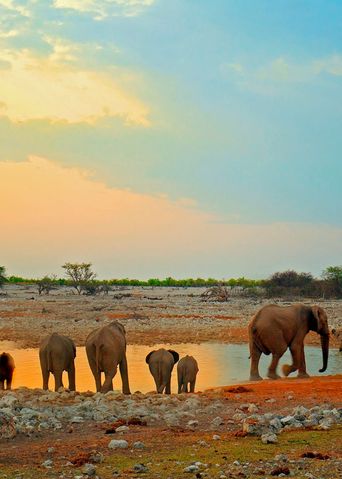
[{"x1": 0, "y1": 375, "x2": 342, "y2": 479}]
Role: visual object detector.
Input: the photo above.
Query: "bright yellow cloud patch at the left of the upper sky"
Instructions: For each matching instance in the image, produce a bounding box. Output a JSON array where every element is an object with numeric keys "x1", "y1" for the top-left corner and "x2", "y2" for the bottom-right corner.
[{"x1": 0, "y1": 49, "x2": 149, "y2": 126}]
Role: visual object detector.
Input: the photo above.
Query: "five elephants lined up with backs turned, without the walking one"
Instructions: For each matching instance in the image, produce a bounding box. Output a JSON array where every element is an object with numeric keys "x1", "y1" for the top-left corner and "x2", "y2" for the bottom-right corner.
[{"x1": 0, "y1": 321, "x2": 199, "y2": 394}]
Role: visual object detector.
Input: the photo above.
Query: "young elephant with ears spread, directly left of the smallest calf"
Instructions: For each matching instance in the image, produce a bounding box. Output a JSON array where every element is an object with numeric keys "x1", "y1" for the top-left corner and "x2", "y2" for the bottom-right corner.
[{"x1": 146, "y1": 348, "x2": 179, "y2": 394}]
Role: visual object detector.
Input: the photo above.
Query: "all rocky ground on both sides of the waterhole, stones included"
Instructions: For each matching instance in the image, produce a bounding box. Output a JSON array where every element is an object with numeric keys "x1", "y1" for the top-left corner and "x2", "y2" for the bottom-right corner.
[{"x1": 0, "y1": 286, "x2": 342, "y2": 479}]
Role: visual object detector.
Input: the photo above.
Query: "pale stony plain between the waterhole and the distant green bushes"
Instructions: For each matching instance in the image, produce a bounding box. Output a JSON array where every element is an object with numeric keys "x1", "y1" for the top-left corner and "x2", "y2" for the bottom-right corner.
[{"x1": 0, "y1": 285, "x2": 342, "y2": 347}]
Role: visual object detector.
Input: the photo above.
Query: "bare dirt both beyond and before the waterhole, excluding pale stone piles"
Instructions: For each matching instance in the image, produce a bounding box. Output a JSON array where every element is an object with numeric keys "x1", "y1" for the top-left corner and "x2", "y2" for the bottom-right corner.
[{"x1": 0, "y1": 286, "x2": 342, "y2": 479}]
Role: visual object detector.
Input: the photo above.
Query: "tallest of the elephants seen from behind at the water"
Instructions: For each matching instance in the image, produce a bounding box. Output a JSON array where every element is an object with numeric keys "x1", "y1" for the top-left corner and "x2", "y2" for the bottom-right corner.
[{"x1": 85, "y1": 321, "x2": 131, "y2": 394}]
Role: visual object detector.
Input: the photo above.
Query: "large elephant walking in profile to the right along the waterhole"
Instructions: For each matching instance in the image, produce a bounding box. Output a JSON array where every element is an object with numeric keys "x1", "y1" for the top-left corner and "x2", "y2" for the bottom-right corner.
[{"x1": 248, "y1": 304, "x2": 329, "y2": 381}]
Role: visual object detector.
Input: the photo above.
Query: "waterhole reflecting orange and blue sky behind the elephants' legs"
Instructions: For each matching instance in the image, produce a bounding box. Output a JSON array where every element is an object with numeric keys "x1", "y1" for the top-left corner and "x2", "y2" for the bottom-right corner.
[{"x1": 0, "y1": 342, "x2": 342, "y2": 392}]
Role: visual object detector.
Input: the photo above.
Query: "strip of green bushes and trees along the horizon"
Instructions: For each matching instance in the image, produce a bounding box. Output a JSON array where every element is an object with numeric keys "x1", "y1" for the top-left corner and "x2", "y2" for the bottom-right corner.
[{"x1": 0, "y1": 263, "x2": 342, "y2": 300}]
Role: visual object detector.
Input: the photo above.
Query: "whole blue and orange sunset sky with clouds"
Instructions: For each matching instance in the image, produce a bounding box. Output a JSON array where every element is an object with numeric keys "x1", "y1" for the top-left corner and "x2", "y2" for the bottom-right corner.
[{"x1": 0, "y1": 0, "x2": 342, "y2": 279}]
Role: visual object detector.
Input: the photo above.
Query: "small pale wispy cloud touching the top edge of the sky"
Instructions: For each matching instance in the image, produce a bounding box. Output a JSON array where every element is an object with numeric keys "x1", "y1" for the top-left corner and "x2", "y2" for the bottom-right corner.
[{"x1": 54, "y1": 0, "x2": 155, "y2": 20}]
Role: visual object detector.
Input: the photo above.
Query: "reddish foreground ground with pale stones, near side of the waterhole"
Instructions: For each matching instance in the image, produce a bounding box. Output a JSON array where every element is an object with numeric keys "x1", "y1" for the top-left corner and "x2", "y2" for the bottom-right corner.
[{"x1": 0, "y1": 376, "x2": 342, "y2": 479}]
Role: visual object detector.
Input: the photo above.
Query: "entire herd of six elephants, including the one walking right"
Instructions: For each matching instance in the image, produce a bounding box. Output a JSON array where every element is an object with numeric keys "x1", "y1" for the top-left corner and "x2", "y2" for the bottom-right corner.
[{"x1": 0, "y1": 304, "x2": 342, "y2": 394}]
